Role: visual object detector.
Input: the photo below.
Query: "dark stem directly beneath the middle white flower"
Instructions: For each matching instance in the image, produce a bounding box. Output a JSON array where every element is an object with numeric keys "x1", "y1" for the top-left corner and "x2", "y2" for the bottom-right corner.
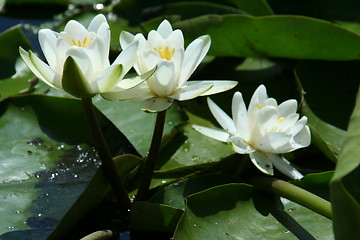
[{"x1": 136, "y1": 110, "x2": 166, "y2": 201}]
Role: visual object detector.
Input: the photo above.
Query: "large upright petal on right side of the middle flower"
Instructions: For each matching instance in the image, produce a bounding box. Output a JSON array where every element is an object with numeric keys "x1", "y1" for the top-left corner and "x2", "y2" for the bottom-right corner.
[{"x1": 179, "y1": 35, "x2": 211, "y2": 85}]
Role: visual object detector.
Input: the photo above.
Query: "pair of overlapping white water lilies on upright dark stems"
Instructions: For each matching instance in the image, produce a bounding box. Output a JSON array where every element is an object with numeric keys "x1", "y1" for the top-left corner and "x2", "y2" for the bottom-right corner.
[{"x1": 20, "y1": 14, "x2": 237, "y2": 105}]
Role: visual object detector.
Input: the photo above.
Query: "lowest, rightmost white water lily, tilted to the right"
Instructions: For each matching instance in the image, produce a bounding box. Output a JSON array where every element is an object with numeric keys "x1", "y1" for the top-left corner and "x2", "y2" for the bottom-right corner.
[{"x1": 193, "y1": 85, "x2": 311, "y2": 179}]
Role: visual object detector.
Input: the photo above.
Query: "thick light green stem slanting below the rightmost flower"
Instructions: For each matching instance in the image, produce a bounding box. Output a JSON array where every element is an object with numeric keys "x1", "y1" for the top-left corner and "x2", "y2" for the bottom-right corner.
[{"x1": 251, "y1": 174, "x2": 332, "y2": 219}]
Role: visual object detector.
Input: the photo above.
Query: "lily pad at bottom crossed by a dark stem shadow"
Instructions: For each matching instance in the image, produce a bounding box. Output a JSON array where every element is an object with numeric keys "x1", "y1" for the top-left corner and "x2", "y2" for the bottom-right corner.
[{"x1": 174, "y1": 184, "x2": 334, "y2": 240}]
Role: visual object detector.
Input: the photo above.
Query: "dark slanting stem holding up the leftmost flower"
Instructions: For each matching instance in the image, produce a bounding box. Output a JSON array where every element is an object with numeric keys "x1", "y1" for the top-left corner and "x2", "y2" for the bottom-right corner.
[{"x1": 81, "y1": 98, "x2": 131, "y2": 212}]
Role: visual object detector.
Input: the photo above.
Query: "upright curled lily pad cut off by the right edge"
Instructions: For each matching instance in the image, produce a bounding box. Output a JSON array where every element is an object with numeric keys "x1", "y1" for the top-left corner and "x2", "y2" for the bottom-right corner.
[{"x1": 330, "y1": 85, "x2": 360, "y2": 240}]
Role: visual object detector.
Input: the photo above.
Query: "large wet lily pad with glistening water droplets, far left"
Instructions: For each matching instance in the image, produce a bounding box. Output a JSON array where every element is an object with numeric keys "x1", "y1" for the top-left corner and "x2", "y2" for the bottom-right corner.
[{"x1": 0, "y1": 95, "x2": 134, "y2": 240}]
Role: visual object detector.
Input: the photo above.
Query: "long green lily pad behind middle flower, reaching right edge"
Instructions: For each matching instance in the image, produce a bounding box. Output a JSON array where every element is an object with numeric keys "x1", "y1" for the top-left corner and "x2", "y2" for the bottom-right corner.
[{"x1": 174, "y1": 15, "x2": 360, "y2": 60}]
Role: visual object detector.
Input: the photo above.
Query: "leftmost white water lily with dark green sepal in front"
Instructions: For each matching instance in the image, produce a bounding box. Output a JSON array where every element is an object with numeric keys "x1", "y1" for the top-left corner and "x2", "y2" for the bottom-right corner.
[{"x1": 20, "y1": 14, "x2": 144, "y2": 97}]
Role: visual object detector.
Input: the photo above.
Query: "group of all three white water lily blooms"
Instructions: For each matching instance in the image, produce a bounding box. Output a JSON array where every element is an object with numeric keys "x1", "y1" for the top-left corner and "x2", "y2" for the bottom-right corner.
[{"x1": 20, "y1": 14, "x2": 310, "y2": 179}]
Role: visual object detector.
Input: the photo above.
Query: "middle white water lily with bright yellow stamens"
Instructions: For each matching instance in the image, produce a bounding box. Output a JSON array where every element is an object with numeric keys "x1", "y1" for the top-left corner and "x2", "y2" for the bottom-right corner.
[{"x1": 102, "y1": 20, "x2": 237, "y2": 112}]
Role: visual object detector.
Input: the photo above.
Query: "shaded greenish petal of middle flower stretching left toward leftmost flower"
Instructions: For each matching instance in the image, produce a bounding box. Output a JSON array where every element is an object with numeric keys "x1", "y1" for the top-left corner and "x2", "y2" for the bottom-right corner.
[{"x1": 101, "y1": 82, "x2": 154, "y2": 101}]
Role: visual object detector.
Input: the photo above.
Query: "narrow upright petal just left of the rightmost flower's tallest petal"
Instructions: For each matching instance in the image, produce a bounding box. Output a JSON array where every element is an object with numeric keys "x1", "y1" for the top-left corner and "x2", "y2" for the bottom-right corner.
[{"x1": 231, "y1": 92, "x2": 250, "y2": 140}]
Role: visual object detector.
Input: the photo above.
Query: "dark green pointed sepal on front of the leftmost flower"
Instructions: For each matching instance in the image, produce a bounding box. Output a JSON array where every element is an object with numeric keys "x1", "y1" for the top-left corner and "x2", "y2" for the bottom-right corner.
[{"x1": 61, "y1": 56, "x2": 94, "y2": 98}]
